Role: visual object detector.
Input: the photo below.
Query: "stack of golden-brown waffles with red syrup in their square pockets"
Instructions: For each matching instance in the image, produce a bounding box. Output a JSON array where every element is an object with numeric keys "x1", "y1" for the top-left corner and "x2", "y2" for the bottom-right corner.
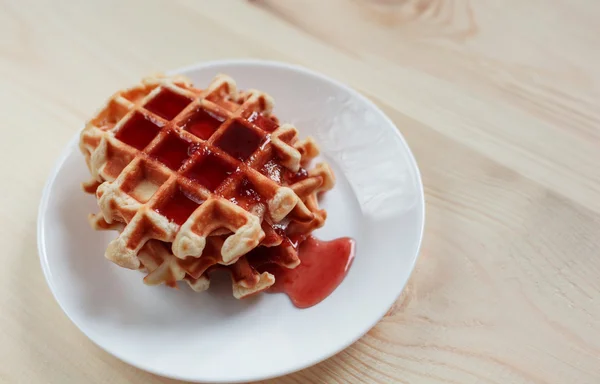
[{"x1": 80, "y1": 75, "x2": 334, "y2": 298}]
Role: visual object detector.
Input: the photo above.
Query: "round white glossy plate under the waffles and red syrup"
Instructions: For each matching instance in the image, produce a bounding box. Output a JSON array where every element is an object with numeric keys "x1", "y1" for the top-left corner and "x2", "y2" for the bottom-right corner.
[{"x1": 38, "y1": 60, "x2": 424, "y2": 382}]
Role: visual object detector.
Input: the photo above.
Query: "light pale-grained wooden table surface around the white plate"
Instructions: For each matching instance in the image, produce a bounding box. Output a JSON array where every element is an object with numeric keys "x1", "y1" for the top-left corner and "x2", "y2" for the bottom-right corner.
[{"x1": 0, "y1": 0, "x2": 600, "y2": 384}]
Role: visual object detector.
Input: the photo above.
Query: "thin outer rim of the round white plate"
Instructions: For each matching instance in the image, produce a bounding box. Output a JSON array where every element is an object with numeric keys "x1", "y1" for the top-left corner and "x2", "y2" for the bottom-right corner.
[{"x1": 37, "y1": 59, "x2": 426, "y2": 383}]
